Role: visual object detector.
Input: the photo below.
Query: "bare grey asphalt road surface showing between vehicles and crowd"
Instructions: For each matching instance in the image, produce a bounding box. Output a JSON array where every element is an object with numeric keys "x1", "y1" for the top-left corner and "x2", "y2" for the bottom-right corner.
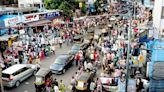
[{"x1": 5, "y1": 45, "x2": 77, "y2": 92}]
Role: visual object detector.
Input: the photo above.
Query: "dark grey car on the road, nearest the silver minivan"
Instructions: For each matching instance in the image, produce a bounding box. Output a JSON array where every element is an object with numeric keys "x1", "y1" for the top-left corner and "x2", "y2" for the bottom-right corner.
[{"x1": 50, "y1": 55, "x2": 74, "y2": 74}]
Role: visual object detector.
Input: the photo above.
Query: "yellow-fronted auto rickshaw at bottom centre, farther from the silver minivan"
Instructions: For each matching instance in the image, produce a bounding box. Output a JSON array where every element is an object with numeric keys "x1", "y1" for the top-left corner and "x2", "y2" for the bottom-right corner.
[{"x1": 76, "y1": 72, "x2": 94, "y2": 92}]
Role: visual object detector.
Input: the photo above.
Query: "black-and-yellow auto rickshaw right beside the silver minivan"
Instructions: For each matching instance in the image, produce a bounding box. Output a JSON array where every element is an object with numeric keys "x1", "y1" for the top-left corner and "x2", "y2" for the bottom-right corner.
[{"x1": 34, "y1": 68, "x2": 52, "y2": 92}]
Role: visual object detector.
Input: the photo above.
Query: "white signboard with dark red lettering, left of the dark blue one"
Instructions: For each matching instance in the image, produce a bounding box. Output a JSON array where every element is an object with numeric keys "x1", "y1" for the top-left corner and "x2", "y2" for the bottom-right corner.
[{"x1": 22, "y1": 15, "x2": 39, "y2": 23}]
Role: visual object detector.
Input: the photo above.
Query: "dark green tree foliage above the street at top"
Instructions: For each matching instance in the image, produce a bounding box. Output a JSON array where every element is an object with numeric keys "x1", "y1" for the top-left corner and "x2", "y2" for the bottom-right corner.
[{"x1": 44, "y1": 0, "x2": 79, "y2": 16}]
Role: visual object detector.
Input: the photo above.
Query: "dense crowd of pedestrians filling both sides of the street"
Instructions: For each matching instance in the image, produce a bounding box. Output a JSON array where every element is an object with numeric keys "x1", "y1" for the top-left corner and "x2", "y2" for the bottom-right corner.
[{"x1": 1, "y1": 1, "x2": 152, "y2": 92}]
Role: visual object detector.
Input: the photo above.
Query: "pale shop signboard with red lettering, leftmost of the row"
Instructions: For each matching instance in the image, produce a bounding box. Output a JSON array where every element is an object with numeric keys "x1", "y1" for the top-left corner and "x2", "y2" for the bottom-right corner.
[{"x1": 4, "y1": 16, "x2": 20, "y2": 27}]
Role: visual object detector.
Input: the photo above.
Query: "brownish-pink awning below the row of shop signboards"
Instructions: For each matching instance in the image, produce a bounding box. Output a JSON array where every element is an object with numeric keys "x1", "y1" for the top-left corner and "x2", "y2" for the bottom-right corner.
[{"x1": 26, "y1": 20, "x2": 52, "y2": 27}]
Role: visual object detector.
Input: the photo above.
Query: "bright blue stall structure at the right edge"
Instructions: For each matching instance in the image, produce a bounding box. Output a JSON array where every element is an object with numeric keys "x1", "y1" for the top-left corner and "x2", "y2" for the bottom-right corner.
[{"x1": 148, "y1": 40, "x2": 164, "y2": 92}]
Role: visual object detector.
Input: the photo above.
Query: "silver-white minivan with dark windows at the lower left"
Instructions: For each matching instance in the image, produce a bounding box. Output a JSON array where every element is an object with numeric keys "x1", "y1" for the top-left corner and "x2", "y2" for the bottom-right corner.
[{"x1": 2, "y1": 64, "x2": 37, "y2": 87}]
